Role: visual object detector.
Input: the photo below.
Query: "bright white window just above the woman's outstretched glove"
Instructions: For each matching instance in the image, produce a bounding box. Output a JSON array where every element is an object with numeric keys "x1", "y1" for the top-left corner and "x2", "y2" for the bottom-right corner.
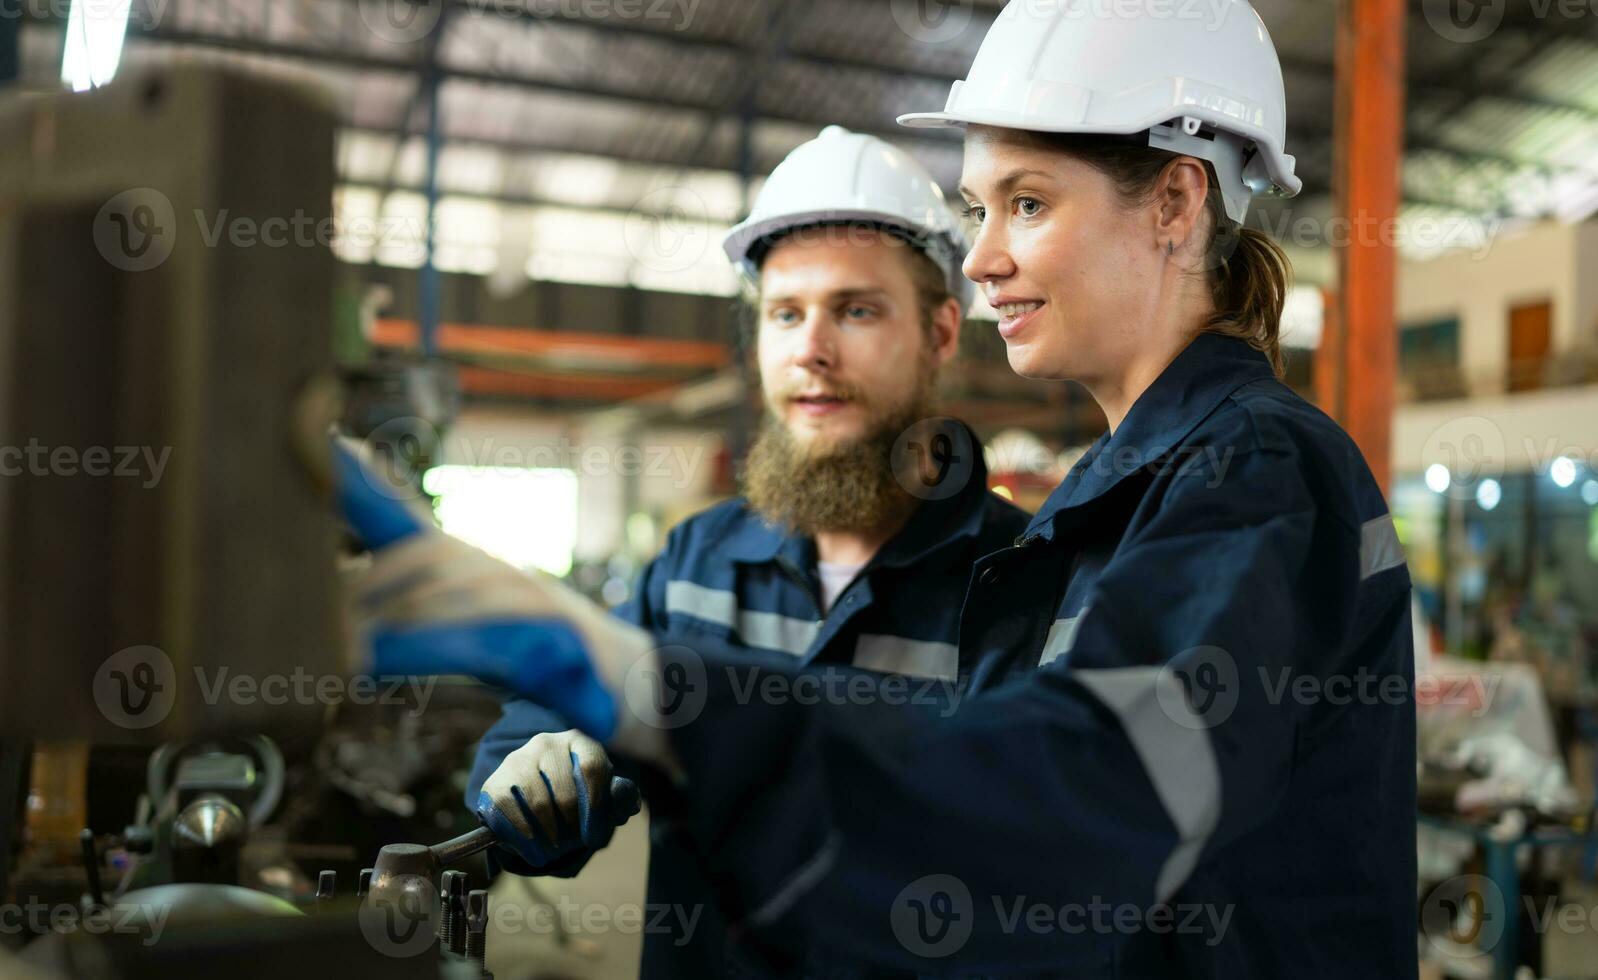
[{"x1": 423, "y1": 465, "x2": 577, "y2": 576}]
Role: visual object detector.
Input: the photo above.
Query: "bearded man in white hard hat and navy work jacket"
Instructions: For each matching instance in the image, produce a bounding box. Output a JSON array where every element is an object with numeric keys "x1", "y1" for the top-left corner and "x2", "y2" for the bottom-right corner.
[{"x1": 465, "y1": 126, "x2": 1028, "y2": 978}]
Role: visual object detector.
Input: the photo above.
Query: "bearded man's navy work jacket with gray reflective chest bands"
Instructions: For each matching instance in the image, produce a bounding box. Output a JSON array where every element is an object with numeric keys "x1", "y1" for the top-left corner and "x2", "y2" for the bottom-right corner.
[{"x1": 465, "y1": 419, "x2": 1028, "y2": 980}]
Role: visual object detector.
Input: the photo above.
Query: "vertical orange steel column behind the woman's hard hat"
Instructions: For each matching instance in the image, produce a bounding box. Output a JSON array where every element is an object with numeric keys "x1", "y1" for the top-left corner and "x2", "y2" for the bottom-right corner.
[{"x1": 1323, "y1": 0, "x2": 1405, "y2": 488}]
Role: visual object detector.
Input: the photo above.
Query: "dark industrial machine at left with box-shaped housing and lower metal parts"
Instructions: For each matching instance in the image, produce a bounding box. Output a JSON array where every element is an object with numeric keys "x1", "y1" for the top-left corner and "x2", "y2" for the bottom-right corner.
[{"x1": 0, "y1": 64, "x2": 543, "y2": 980}]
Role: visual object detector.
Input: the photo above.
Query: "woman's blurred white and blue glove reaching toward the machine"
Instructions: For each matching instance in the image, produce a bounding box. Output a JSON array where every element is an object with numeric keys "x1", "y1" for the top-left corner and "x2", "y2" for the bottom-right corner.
[{"x1": 332, "y1": 440, "x2": 670, "y2": 761}]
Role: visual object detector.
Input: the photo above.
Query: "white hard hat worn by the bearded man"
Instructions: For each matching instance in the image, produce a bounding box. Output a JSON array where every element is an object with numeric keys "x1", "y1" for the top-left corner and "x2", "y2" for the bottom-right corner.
[{"x1": 722, "y1": 126, "x2": 975, "y2": 310}]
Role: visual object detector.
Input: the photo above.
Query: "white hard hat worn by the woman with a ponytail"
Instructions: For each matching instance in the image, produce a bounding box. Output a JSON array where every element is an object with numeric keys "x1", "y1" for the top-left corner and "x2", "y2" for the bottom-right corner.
[{"x1": 898, "y1": 0, "x2": 1302, "y2": 224}]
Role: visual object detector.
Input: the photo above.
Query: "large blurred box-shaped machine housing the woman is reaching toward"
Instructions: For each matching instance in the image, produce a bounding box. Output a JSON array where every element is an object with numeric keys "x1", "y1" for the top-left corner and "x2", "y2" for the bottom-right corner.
[{"x1": 0, "y1": 64, "x2": 344, "y2": 744}]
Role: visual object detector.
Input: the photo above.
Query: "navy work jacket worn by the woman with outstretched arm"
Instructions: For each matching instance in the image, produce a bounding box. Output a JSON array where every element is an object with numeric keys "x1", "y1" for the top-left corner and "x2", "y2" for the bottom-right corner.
[{"x1": 663, "y1": 334, "x2": 1417, "y2": 980}]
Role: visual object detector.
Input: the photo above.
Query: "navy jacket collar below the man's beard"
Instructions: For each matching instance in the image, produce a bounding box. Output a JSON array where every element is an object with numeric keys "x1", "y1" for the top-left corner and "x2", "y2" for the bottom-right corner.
[{"x1": 727, "y1": 419, "x2": 991, "y2": 569}]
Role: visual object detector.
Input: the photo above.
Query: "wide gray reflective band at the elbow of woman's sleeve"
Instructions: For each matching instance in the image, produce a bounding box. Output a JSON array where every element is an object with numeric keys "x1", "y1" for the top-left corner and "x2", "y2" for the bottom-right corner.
[{"x1": 1071, "y1": 667, "x2": 1221, "y2": 902}]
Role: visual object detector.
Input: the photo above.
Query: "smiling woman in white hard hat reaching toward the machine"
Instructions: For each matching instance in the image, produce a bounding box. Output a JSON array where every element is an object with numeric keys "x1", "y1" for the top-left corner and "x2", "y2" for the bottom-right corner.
[{"x1": 343, "y1": 0, "x2": 1416, "y2": 980}]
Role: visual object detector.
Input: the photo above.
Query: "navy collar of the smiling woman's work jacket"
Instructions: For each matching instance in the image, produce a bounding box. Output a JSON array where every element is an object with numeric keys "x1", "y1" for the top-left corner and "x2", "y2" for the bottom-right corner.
[{"x1": 1028, "y1": 333, "x2": 1275, "y2": 539}]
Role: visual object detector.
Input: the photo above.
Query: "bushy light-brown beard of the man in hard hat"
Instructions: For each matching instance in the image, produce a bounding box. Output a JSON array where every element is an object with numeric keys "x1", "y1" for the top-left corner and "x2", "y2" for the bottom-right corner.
[{"x1": 743, "y1": 363, "x2": 936, "y2": 536}]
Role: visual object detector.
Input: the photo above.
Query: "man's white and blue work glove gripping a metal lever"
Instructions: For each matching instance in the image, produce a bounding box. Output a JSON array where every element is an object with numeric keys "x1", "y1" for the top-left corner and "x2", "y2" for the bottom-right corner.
[{"x1": 476, "y1": 731, "x2": 642, "y2": 871}]
